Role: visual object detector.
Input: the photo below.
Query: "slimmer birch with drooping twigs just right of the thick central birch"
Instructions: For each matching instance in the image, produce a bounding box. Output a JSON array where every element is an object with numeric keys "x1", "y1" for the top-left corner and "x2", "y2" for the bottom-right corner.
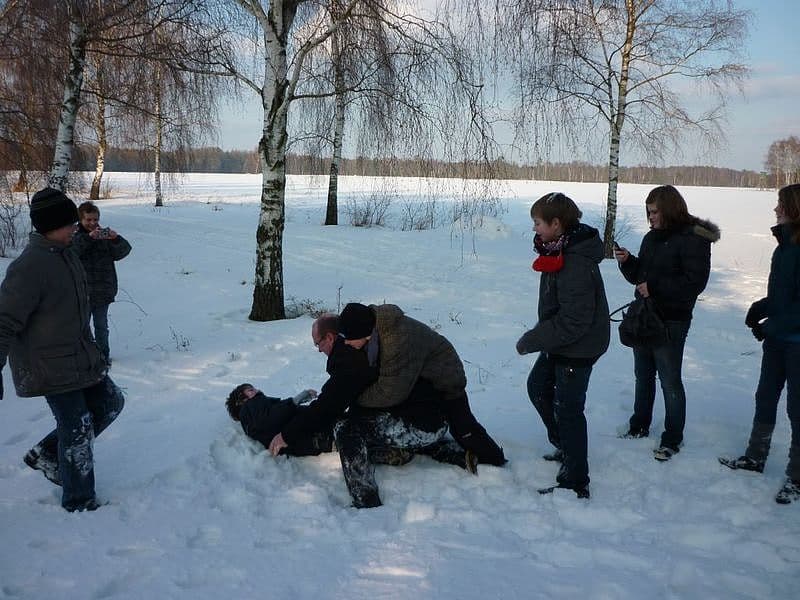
[{"x1": 296, "y1": 0, "x2": 486, "y2": 225}]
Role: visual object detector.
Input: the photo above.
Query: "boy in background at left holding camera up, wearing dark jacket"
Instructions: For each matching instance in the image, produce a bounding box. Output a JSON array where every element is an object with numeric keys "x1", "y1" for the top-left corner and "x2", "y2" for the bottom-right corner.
[{"x1": 72, "y1": 202, "x2": 131, "y2": 365}]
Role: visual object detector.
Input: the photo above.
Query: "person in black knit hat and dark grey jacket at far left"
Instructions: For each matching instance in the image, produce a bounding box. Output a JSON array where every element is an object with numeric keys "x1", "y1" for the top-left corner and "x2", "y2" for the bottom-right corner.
[{"x1": 0, "y1": 188, "x2": 125, "y2": 511}]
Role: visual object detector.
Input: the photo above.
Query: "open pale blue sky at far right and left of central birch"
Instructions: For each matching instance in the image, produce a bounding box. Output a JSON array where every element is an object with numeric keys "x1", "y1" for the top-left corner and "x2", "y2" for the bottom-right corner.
[{"x1": 214, "y1": 0, "x2": 800, "y2": 171}]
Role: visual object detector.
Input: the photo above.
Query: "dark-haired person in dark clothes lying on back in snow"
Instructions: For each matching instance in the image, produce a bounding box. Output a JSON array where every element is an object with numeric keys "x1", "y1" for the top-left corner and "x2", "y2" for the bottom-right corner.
[{"x1": 225, "y1": 383, "x2": 333, "y2": 456}]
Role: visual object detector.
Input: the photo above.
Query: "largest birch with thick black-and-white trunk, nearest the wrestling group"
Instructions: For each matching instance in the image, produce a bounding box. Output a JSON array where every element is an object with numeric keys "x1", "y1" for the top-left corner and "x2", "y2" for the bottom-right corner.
[{"x1": 208, "y1": 0, "x2": 494, "y2": 321}]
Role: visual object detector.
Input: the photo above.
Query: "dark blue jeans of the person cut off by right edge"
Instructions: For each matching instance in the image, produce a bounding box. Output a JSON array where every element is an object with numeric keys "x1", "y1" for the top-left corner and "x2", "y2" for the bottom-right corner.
[{"x1": 753, "y1": 338, "x2": 800, "y2": 480}]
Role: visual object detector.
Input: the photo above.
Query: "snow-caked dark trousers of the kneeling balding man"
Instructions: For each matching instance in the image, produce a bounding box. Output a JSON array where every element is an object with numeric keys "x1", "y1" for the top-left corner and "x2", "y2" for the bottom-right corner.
[{"x1": 333, "y1": 412, "x2": 447, "y2": 508}]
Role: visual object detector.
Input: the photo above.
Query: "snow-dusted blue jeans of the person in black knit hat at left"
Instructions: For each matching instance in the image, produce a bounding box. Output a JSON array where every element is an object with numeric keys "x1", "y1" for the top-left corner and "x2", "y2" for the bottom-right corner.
[{"x1": 38, "y1": 376, "x2": 125, "y2": 511}]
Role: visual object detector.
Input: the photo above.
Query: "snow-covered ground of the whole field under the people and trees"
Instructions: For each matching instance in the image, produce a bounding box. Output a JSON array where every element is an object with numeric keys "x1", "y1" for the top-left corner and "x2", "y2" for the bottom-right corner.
[{"x1": 0, "y1": 173, "x2": 800, "y2": 600}]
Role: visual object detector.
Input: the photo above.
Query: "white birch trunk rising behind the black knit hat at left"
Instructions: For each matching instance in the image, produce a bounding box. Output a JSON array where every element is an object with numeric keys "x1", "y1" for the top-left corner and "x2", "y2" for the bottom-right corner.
[{"x1": 48, "y1": 20, "x2": 87, "y2": 191}]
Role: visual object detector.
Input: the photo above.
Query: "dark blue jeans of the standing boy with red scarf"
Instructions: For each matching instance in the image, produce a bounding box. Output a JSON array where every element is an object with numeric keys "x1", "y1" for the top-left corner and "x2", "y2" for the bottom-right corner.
[{"x1": 528, "y1": 352, "x2": 592, "y2": 489}]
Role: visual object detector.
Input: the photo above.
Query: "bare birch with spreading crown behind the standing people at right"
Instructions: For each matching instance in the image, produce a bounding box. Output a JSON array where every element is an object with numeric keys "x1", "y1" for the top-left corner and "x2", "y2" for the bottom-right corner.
[{"x1": 503, "y1": 0, "x2": 749, "y2": 256}]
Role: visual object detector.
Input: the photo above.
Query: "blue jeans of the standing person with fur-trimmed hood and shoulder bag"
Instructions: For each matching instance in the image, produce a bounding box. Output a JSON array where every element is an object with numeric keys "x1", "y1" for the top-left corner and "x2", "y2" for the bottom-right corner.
[{"x1": 630, "y1": 321, "x2": 691, "y2": 450}]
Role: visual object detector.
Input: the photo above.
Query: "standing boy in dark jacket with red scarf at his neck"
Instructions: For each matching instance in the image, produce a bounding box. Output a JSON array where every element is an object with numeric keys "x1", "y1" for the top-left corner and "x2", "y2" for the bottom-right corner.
[{"x1": 517, "y1": 192, "x2": 610, "y2": 498}]
